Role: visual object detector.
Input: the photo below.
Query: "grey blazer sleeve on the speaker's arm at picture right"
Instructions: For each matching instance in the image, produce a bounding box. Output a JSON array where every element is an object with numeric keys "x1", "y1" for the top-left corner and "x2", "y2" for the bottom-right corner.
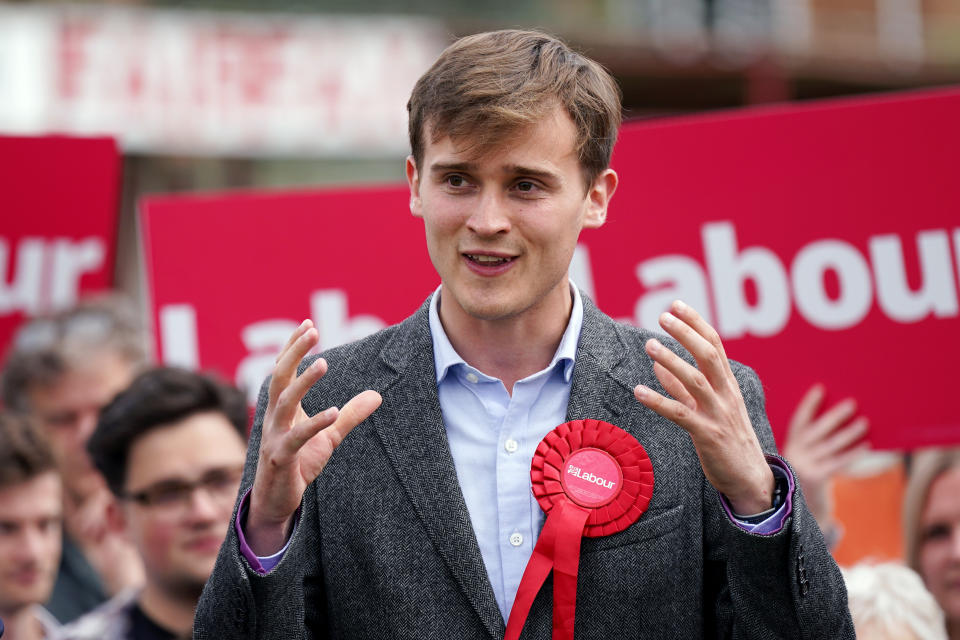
[{"x1": 703, "y1": 363, "x2": 855, "y2": 640}]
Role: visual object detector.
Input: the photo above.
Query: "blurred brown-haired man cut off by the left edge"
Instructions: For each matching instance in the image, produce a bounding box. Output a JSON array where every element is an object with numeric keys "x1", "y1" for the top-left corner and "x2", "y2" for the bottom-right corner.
[{"x1": 0, "y1": 413, "x2": 63, "y2": 640}]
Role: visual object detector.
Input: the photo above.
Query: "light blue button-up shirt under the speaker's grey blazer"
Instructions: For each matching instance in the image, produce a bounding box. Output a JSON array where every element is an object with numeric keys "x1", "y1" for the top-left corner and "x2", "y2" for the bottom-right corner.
[{"x1": 430, "y1": 285, "x2": 583, "y2": 620}]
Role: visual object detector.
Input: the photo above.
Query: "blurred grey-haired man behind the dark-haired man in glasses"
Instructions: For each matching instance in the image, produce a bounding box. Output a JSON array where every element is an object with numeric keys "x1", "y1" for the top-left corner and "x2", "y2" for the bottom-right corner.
[{"x1": 2, "y1": 298, "x2": 147, "y2": 622}]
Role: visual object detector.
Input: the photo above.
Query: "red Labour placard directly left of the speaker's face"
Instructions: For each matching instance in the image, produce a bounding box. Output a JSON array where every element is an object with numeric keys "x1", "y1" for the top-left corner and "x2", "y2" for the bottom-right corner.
[{"x1": 141, "y1": 186, "x2": 440, "y2": 400}]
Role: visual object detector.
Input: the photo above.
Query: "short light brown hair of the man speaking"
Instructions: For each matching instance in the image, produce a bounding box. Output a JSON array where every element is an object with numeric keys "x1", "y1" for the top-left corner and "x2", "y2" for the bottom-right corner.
[{"x1": 407, "y1": 30, "x2": 621, "y2": 186}]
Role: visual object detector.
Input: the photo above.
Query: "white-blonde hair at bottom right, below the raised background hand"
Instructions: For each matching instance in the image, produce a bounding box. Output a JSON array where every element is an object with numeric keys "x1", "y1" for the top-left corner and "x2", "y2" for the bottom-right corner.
[{"x1": 841, "y1": 562, "x2": 947, "y2": 640}]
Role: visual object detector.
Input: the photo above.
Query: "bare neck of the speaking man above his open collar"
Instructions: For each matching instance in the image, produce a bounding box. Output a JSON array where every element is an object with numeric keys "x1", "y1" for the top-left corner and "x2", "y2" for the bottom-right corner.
[{"x1": 438, "y1": 282, "x2": 573, "y2": 394}]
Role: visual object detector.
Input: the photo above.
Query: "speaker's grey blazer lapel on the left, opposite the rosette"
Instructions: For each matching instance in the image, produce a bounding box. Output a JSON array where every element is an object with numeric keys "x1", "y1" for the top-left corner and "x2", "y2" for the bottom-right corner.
[{"x1": 374, "y1": 300, "x2": 504, "y2": 638}]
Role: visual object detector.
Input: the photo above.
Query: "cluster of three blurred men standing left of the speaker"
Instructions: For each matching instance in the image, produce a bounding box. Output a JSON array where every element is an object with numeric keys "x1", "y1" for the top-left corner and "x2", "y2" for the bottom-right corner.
[{"x1": 0, "y1": 298, "x2": 249, "y2": 640}]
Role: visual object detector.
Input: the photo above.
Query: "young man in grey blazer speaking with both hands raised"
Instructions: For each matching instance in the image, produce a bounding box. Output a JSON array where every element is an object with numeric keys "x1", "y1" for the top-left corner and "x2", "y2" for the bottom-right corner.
[{"x1": 194, "y1": 31, "x2": 853, "y2": 640}]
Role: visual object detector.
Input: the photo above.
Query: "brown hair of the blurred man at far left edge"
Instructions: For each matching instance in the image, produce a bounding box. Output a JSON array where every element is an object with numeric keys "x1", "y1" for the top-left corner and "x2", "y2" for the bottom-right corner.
[{"x1": 0, "y1": 411, "x2": 57, "y2": 489}]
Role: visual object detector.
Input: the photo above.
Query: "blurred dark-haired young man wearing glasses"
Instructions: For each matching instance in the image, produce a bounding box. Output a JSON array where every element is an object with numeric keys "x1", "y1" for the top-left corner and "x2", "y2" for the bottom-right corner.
[{"x1": 63, "y1": 368, "x2": 248, "y2": 640}]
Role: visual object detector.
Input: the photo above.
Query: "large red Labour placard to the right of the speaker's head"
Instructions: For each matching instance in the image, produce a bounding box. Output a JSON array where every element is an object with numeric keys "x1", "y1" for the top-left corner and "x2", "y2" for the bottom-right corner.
[{"x1": 600, "y1": 89, "x2": 960, "y2": 448}]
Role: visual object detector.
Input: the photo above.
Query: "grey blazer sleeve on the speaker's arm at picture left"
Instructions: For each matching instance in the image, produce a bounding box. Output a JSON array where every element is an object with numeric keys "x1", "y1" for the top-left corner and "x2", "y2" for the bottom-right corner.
[{"x1": 193, "y1": 378, "x2": 324, "y2": 640}]
